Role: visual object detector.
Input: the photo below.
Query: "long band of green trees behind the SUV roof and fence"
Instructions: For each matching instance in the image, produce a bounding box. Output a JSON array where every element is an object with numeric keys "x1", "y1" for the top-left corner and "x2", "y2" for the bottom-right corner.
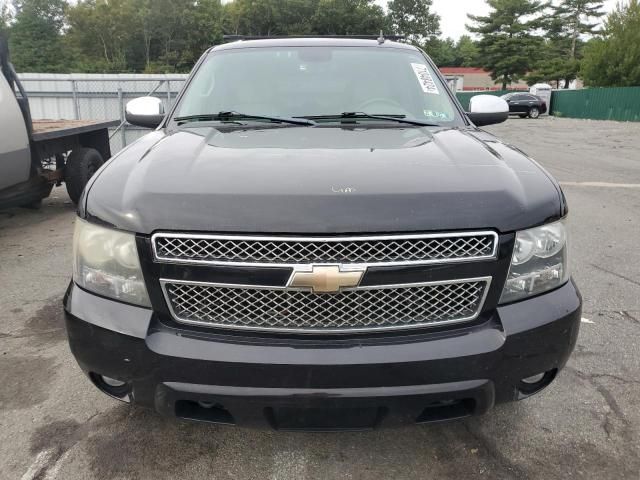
[{"x1": 0, "y1": 0, "x2": 478, "y2": 73}]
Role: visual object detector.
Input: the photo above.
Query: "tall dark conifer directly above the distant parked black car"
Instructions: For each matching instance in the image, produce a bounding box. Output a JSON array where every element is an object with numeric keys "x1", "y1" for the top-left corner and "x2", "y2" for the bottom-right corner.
[{"x1": 467, "y1": 0, "x2": 544, "y2": 90}]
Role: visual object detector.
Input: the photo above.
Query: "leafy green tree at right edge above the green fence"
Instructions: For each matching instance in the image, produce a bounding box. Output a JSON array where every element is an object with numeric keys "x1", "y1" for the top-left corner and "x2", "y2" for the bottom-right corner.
[{"x1": 581, "y1": 0, "x2": 640, "y2": 87}]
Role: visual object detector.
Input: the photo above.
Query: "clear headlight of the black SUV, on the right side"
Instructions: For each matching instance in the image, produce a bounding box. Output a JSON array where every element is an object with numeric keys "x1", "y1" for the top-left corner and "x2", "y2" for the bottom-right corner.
[{"x1": 500, "y1": 220, "x2": 569, "y2": 303}]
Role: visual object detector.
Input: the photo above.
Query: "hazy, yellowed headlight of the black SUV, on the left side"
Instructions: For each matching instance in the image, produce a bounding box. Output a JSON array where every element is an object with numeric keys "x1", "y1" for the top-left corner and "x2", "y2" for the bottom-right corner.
[{"x1": 73, "y1": 218, "x2": 151, "y2": 307}]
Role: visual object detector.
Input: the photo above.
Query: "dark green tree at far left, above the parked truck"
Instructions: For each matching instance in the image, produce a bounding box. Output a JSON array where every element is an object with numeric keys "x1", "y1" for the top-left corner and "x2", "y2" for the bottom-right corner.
[{"x1": 9, "y1": 0, "x2": 69, "y2": 72}]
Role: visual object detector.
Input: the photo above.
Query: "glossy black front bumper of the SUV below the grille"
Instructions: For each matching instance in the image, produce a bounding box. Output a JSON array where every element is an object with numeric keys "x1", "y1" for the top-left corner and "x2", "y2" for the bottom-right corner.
[{"x1": 65, "y1": 282, "x2": 581, "y2": 430}]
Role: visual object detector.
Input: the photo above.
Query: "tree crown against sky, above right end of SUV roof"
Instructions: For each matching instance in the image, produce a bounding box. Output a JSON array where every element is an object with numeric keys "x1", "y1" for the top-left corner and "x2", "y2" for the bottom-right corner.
[{"x1": 387, "y1": 0, "x2": 440, "y2": 45}]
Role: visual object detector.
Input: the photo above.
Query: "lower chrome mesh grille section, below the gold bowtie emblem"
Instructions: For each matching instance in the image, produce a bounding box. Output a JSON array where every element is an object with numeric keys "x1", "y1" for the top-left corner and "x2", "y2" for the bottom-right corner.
[{"x1": 162, "y1": 278, "x2": 489, "y2": 333}]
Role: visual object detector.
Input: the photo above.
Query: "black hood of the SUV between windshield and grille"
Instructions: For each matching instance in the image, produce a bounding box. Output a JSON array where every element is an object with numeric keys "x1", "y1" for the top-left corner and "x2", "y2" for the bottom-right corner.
[{"x1": 86, "y1": 126, "x2": 565, "y2": 234}]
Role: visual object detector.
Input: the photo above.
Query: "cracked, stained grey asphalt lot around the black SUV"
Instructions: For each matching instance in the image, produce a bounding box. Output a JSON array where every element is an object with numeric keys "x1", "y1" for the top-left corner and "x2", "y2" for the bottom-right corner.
[{"x1": 0, "y1": 118, "x2": 640, "y2": 480}]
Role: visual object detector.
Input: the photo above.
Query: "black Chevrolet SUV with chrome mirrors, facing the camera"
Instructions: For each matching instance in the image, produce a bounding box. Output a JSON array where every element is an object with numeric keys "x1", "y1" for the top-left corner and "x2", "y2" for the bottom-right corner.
[{"x1": 65, "y1": 38, "x2": 581, "y2": 430}]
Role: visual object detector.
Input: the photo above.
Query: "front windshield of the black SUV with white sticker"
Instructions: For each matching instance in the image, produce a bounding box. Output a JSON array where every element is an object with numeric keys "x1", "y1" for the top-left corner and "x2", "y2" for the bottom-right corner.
[{"x1": 174, "y1": 47, "x2": 462, "y2": 126}]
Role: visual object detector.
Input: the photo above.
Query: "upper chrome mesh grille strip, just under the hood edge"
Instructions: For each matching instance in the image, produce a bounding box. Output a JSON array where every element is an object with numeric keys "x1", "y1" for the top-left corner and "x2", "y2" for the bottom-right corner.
[{"x1": 153, "y1": 232, "x2": 497, "y2": 266}]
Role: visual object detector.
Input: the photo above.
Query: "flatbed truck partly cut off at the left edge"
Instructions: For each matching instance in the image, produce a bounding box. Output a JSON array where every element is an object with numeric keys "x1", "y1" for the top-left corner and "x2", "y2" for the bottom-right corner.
[{"x1": 0, "y1": 31, "x2": 120, "y2": 209}]
